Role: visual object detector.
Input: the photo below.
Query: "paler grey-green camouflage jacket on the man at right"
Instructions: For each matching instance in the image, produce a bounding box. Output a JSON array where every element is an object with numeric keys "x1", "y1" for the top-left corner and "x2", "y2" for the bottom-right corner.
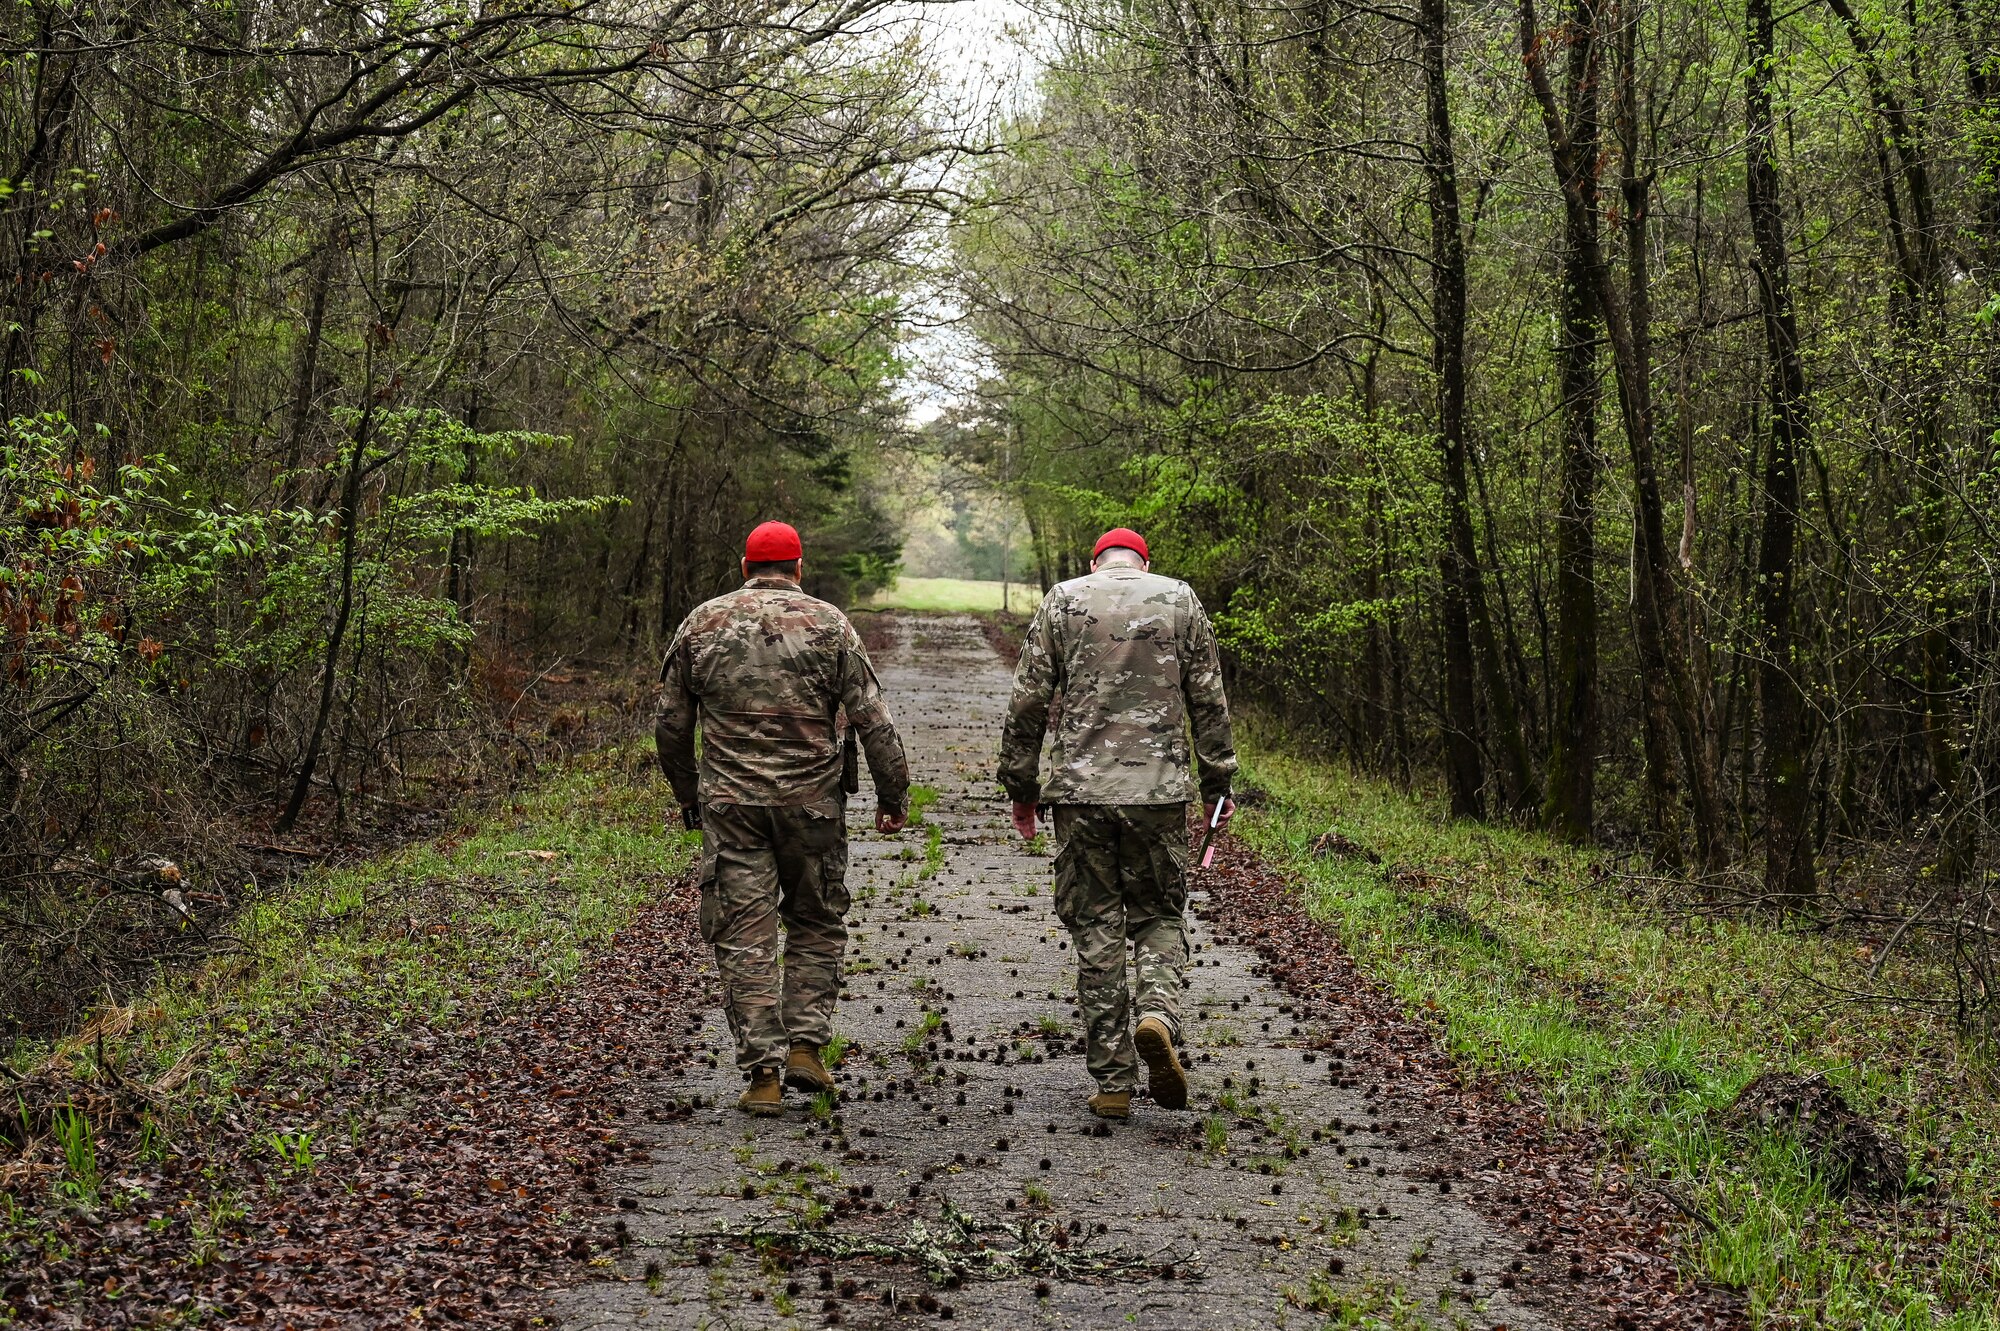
[{"x1": 1000, "y1": 564, "x2": 1236, "y2": 803}]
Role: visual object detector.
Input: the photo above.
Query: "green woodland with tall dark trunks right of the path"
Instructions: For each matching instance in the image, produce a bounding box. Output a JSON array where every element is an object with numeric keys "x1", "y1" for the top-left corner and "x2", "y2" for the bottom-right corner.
[{"x1": 954, "y1": 0, "x2": 2000, "y2": 903}]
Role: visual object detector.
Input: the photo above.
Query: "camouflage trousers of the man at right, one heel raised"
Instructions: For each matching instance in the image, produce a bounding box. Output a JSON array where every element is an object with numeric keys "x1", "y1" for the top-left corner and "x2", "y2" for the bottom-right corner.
[{"x1": 1056, "y1": 803, "x2": 1188, "y2": 1091}]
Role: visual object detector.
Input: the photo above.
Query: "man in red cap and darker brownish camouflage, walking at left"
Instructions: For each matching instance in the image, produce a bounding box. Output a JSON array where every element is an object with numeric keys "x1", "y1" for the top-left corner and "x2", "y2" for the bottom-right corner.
[{"x1": 654, "y1": 522, "x2": 910, "y2": 1115}]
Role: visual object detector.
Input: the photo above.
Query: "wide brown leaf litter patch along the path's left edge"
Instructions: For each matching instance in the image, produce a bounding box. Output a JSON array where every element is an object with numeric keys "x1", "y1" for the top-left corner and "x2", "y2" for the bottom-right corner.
[{"x1": 0, "y1": 879, "x2": 710, "y2": 1331}]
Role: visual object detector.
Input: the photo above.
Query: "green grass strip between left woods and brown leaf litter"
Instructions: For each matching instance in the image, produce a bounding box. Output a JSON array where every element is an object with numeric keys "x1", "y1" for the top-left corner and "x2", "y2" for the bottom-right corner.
[{"x1": 12, "y1": 735, "x2": 696, "y2": 1151}]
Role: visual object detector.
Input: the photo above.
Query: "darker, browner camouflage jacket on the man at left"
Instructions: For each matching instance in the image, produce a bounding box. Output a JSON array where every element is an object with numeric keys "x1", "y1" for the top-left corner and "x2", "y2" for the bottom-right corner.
[{"x1": 652, "y1": 578, "x2": 910, "y2": 813}]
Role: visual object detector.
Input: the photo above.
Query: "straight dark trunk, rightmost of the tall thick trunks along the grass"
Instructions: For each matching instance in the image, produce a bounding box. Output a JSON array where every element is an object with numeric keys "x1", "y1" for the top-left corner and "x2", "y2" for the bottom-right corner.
[{"x1": 1744, "y1": 0, "x2": 1814, "y2": 907}]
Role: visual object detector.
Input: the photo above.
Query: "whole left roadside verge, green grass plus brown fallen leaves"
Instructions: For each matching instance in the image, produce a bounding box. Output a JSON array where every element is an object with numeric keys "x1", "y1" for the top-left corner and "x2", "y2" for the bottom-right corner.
[{"x1": 0, "y1": 739, "x2": 700, "y2": 1327}]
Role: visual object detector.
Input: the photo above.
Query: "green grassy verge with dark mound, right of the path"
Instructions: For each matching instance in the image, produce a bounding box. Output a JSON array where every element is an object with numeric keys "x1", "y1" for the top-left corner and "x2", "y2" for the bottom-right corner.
[{"x1": 1238, "y1": 743, "x2": 2000, "y2": 1331}]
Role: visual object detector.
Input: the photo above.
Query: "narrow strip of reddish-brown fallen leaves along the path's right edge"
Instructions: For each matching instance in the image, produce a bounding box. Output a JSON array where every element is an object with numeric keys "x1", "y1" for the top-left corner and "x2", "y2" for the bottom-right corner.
[{"x1": 1200, "y1": 835, "x2": 1746, "y2": 1331}]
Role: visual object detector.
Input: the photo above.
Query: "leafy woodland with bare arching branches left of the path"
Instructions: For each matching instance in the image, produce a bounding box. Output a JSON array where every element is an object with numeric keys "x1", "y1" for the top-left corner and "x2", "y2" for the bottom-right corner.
[{"x1": 0, "y1": 4, "x2": 964, "y2": 1031}]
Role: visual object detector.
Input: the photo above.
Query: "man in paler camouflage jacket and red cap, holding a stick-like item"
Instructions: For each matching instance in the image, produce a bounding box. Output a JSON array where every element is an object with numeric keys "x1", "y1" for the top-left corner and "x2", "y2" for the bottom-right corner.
[{"x1": 1000, "y1": 528, "x2": 1236, "y2": 1119}]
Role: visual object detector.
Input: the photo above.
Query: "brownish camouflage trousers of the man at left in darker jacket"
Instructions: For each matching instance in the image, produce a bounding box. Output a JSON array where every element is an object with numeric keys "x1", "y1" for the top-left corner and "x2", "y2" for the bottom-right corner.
[{"x1": 702, "y1": 803, "x2": 848, "y2": 1071}]
